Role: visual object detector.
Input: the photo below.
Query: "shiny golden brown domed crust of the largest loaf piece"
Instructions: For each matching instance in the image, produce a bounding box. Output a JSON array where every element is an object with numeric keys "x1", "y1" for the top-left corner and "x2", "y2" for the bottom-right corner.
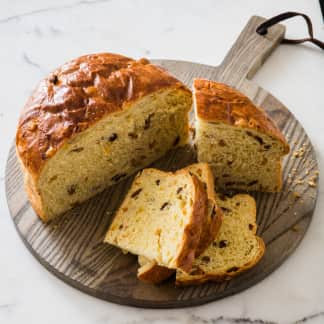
[{"x1": 16, "y1": 53, "x2": 190, "y2": 178}]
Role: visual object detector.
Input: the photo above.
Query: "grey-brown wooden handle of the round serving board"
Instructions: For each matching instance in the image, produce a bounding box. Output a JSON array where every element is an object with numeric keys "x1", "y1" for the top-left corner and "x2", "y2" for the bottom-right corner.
[{"x1": 217, "y1": 16, "x2": 285, "y2": 88}]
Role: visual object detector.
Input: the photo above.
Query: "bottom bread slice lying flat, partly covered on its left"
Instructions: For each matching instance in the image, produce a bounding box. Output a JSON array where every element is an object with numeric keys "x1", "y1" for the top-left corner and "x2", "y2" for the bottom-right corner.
[{"x1": 176, "y1": 194, "x2": 265, "y2": 286}]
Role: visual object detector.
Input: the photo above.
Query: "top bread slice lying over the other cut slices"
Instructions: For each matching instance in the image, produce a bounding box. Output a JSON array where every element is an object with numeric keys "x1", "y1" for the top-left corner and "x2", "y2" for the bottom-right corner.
[{"x1": 105, "y1": 169, "x2": 207, "y2": 271}]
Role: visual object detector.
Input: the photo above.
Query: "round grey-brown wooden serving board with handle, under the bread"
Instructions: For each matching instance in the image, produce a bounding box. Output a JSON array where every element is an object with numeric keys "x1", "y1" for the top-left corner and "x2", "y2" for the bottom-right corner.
[{"x1": 6, "y1": 17, "x2": 317, "y2": 308}]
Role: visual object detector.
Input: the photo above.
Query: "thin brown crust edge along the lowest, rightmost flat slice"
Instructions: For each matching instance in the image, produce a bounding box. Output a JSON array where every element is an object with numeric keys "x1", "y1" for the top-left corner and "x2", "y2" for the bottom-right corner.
[{"x1": 176, "y1": 236, "x2": 265, "y2": 287}]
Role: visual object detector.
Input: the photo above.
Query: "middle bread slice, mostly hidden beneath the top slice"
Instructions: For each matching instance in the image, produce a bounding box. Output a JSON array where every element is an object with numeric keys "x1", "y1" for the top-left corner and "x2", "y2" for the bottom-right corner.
[{"x1": 137, "y1": 163, "x2": 223, "y2": 284}]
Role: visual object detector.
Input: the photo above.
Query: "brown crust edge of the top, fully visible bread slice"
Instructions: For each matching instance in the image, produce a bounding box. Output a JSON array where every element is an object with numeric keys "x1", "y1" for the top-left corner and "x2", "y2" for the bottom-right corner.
[{"x1": 174, "y1": 170, "x2": 208, "y2": 272}]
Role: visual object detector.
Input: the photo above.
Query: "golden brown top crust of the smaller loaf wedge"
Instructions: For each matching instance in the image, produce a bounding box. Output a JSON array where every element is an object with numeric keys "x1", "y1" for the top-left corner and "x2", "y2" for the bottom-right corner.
[{"x1": 194, "y1": 79, "x2": 289, "y2": 154}]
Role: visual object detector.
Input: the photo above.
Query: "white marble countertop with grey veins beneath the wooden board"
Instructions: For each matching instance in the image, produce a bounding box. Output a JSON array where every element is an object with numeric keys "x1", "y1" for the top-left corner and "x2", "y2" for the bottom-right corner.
[{"x1": 0, "y1": 0, "x2": 324, "y2": 324}]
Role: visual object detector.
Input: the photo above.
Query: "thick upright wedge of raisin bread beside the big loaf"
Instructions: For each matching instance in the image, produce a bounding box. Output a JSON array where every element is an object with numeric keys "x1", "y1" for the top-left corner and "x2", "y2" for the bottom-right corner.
[{"x1": 194, "y1": 79, "x2": 289, "y2": 192}]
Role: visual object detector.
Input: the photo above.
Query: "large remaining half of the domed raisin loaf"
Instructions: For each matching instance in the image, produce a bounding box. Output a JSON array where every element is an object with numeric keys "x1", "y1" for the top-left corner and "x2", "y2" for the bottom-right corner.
[{"x1": 16, "y1": 53, "x2": 192, "y2": 221}]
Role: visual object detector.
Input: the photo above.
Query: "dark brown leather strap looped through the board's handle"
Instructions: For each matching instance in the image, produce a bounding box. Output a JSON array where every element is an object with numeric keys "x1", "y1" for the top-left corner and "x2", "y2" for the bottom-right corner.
[{"x1": 256, "y1": 11, "x2": 324, "y2": 50}]
